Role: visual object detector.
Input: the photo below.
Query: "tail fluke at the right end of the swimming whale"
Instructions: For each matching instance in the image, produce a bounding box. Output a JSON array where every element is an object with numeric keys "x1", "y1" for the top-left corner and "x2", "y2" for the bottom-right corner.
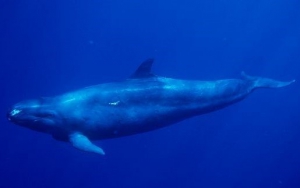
[{"x1": 241, "y1": 72, "x2": 296, "y2": 88}]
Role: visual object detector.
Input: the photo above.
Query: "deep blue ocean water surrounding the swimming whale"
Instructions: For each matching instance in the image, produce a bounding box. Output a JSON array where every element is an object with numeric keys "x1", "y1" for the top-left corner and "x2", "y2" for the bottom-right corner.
[{"x1": 0, "y1": 0, "x2": 300, "y2": 188}]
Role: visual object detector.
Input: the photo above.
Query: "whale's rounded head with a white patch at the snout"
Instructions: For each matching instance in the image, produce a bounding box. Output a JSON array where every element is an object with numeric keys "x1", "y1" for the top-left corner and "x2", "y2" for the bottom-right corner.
[{"x1": 7, "y1": 98, "x2": 57, "y2": 132}]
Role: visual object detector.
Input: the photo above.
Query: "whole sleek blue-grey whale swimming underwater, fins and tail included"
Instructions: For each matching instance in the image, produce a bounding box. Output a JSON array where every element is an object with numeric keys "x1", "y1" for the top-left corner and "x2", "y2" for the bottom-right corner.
[{"x1": 7, "y1": 59, "x2": 295, "y2": 155}]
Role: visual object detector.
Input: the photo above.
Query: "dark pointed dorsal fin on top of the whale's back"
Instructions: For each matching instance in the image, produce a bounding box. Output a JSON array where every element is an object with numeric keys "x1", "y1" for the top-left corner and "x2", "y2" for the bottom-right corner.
[{"x1": 130, "y1": 58, "x2": 155, "y2": 79}]
